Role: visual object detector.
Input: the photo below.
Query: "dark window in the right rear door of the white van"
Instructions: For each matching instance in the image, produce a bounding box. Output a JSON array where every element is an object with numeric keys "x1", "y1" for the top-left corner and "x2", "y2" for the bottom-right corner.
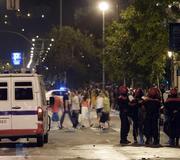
[{"x1": 15, "y1": 82, "x2": 33, "y2": 100}]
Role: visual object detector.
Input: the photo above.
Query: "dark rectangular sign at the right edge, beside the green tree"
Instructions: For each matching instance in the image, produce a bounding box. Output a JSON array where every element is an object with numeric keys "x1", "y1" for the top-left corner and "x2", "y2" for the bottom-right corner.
[{"x1": 169, "y1": 23, "x2": 180, "y2": 52}]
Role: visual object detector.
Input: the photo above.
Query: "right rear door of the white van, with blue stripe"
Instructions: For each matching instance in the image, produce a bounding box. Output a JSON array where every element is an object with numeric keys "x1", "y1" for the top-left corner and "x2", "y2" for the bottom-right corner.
[{"x1": 12, "y1": 77, "x2": 38, "y2": 133}]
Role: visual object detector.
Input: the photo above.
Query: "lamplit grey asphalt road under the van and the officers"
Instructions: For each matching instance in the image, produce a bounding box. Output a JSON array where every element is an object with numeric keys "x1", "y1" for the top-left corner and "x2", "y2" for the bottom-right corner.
[{"x1": 0, "y1": 110, "x2": 180, "y2": 160}]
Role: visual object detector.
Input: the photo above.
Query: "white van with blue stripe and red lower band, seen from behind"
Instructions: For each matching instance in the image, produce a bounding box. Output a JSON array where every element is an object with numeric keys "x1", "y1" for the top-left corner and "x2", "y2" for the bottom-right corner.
[{"x1": 0, "y1": 73, "x2": 50, "y2": 146}]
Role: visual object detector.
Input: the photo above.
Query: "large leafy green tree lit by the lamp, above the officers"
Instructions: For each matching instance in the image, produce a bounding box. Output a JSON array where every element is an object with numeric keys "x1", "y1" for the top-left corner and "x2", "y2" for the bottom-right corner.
[{"x1": 106, "y1": 0, "x2": 179, "y2": 86}]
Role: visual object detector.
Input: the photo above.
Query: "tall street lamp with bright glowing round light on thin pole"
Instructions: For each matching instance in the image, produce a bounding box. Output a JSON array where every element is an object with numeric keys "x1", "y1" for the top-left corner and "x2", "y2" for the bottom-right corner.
[{"x1": 99, "y1": 1, "x2": 109, "y2": 89}]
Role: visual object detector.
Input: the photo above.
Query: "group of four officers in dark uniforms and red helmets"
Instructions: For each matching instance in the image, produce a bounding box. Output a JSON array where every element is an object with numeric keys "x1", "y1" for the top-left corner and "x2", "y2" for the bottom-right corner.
[{"x1": 118, "y1": 86, "x2": 180, "y2": 146}]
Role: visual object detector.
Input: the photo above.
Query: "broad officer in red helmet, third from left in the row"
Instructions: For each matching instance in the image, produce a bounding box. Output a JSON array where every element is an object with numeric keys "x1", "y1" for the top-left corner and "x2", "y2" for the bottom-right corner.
[{"x1": 143, "y1": 87, "x2": 161, "y2": 145}]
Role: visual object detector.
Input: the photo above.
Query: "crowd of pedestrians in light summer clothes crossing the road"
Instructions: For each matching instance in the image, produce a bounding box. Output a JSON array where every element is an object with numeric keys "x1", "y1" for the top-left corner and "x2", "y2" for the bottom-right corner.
[{"x1": 50, "y1": 89, "x2": 111, "y2": 129}]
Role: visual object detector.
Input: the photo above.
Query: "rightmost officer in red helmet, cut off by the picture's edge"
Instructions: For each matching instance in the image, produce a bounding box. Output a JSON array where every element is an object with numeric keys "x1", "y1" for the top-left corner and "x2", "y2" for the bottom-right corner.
[{"x1": 164, "y1": 88, "x2": 180, "y2": 146}]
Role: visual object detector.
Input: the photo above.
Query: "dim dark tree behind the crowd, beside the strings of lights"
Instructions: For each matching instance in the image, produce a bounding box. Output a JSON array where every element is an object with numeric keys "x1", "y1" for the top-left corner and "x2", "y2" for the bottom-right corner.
[{"x1": 42, "y1": 27, "x2": 101, "y2": 87}]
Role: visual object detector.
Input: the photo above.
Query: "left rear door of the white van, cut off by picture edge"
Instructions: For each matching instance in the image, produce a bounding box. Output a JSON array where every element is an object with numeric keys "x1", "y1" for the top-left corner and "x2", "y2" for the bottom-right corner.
[{"x1": 0, "y1": 77, "x2": 11, "y2": 131}]
